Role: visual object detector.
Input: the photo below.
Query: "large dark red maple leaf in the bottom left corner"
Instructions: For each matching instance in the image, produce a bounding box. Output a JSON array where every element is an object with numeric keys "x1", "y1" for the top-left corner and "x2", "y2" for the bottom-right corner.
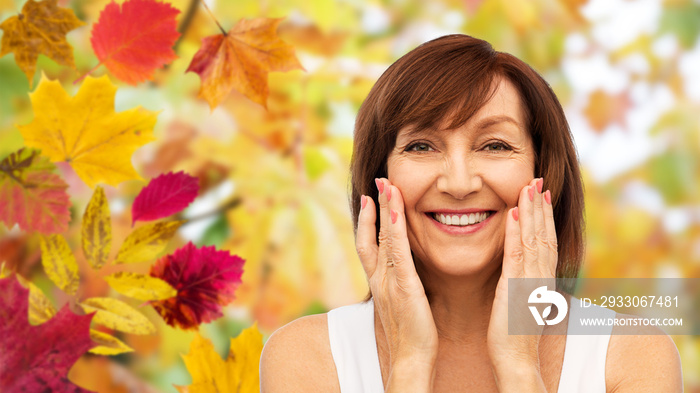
[{"x1": 0, "y1": 276, "x2": 95, "y2": 393}]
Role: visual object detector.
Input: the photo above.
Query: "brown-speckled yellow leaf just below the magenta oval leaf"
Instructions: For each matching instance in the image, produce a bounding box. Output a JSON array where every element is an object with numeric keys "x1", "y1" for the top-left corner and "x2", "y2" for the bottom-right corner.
[{"x1": 115, "y1": 221, "x2": 184, "y2": 263}]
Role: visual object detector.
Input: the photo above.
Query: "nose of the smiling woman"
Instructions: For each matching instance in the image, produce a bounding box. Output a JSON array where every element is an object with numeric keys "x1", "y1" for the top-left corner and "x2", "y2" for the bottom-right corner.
[{"x1": 437, "y1": 156, "x2": 483, "y2": 200}]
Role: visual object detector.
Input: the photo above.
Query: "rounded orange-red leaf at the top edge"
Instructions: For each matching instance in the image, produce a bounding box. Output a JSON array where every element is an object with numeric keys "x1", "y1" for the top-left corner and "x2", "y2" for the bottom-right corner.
[{"x1": 90, "y1": 0, "x2": 180, "y2": 85}]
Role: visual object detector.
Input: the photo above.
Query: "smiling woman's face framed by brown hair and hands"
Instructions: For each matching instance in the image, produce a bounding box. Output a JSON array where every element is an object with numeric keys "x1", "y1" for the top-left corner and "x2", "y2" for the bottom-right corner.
[{"x1": 387, "y1": 79, "x2": 535, "y2": 275}]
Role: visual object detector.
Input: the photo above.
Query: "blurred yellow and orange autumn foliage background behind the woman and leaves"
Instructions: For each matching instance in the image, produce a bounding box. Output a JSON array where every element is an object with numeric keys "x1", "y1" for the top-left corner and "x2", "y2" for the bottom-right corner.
[{"x1": 0, "y1": 0, "x2": 700, "y2": 392}]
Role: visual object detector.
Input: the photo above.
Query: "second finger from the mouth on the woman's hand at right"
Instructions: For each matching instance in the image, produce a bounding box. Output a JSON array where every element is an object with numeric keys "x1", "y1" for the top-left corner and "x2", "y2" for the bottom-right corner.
[{"x1": 518, "y1": 179, "x2": 539, "y2": 277}]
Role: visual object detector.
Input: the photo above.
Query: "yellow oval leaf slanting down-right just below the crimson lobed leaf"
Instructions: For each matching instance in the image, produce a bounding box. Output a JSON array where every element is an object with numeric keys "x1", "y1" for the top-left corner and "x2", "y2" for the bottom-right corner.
[{"x1": 80, "y1": 297, "x2": 156, "y2": 334}]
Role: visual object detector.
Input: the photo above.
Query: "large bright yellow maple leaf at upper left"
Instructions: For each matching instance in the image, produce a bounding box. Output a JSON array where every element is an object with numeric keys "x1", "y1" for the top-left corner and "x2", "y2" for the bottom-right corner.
[{"x1": 18, "y1": 76, "x2": 156, "y2": 187}]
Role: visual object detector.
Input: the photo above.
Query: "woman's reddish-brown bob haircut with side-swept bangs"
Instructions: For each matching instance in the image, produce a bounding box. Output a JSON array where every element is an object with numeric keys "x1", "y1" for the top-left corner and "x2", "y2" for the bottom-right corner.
[{"x1": 350, "y1": 34, "x2": 584, "y2": 282}]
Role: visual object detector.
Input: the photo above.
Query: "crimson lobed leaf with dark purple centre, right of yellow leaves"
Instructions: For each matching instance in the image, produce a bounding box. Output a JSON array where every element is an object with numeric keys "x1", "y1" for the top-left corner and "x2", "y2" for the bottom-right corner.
[{"x1": 151, "y1": 243, "x2": 245, "y2": 329}]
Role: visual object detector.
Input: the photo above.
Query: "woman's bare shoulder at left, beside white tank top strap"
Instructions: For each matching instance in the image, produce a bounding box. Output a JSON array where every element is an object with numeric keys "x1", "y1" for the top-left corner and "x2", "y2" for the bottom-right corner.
[{"x1": 260, "y1": 314, "x2": 340, "y2": 393}]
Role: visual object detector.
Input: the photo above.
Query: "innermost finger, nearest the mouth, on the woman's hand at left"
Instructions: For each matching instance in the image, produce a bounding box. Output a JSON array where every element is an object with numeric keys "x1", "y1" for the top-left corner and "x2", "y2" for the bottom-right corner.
[{"x1": 387, "y1": 183, "x2": 418, "y2": 278}]
